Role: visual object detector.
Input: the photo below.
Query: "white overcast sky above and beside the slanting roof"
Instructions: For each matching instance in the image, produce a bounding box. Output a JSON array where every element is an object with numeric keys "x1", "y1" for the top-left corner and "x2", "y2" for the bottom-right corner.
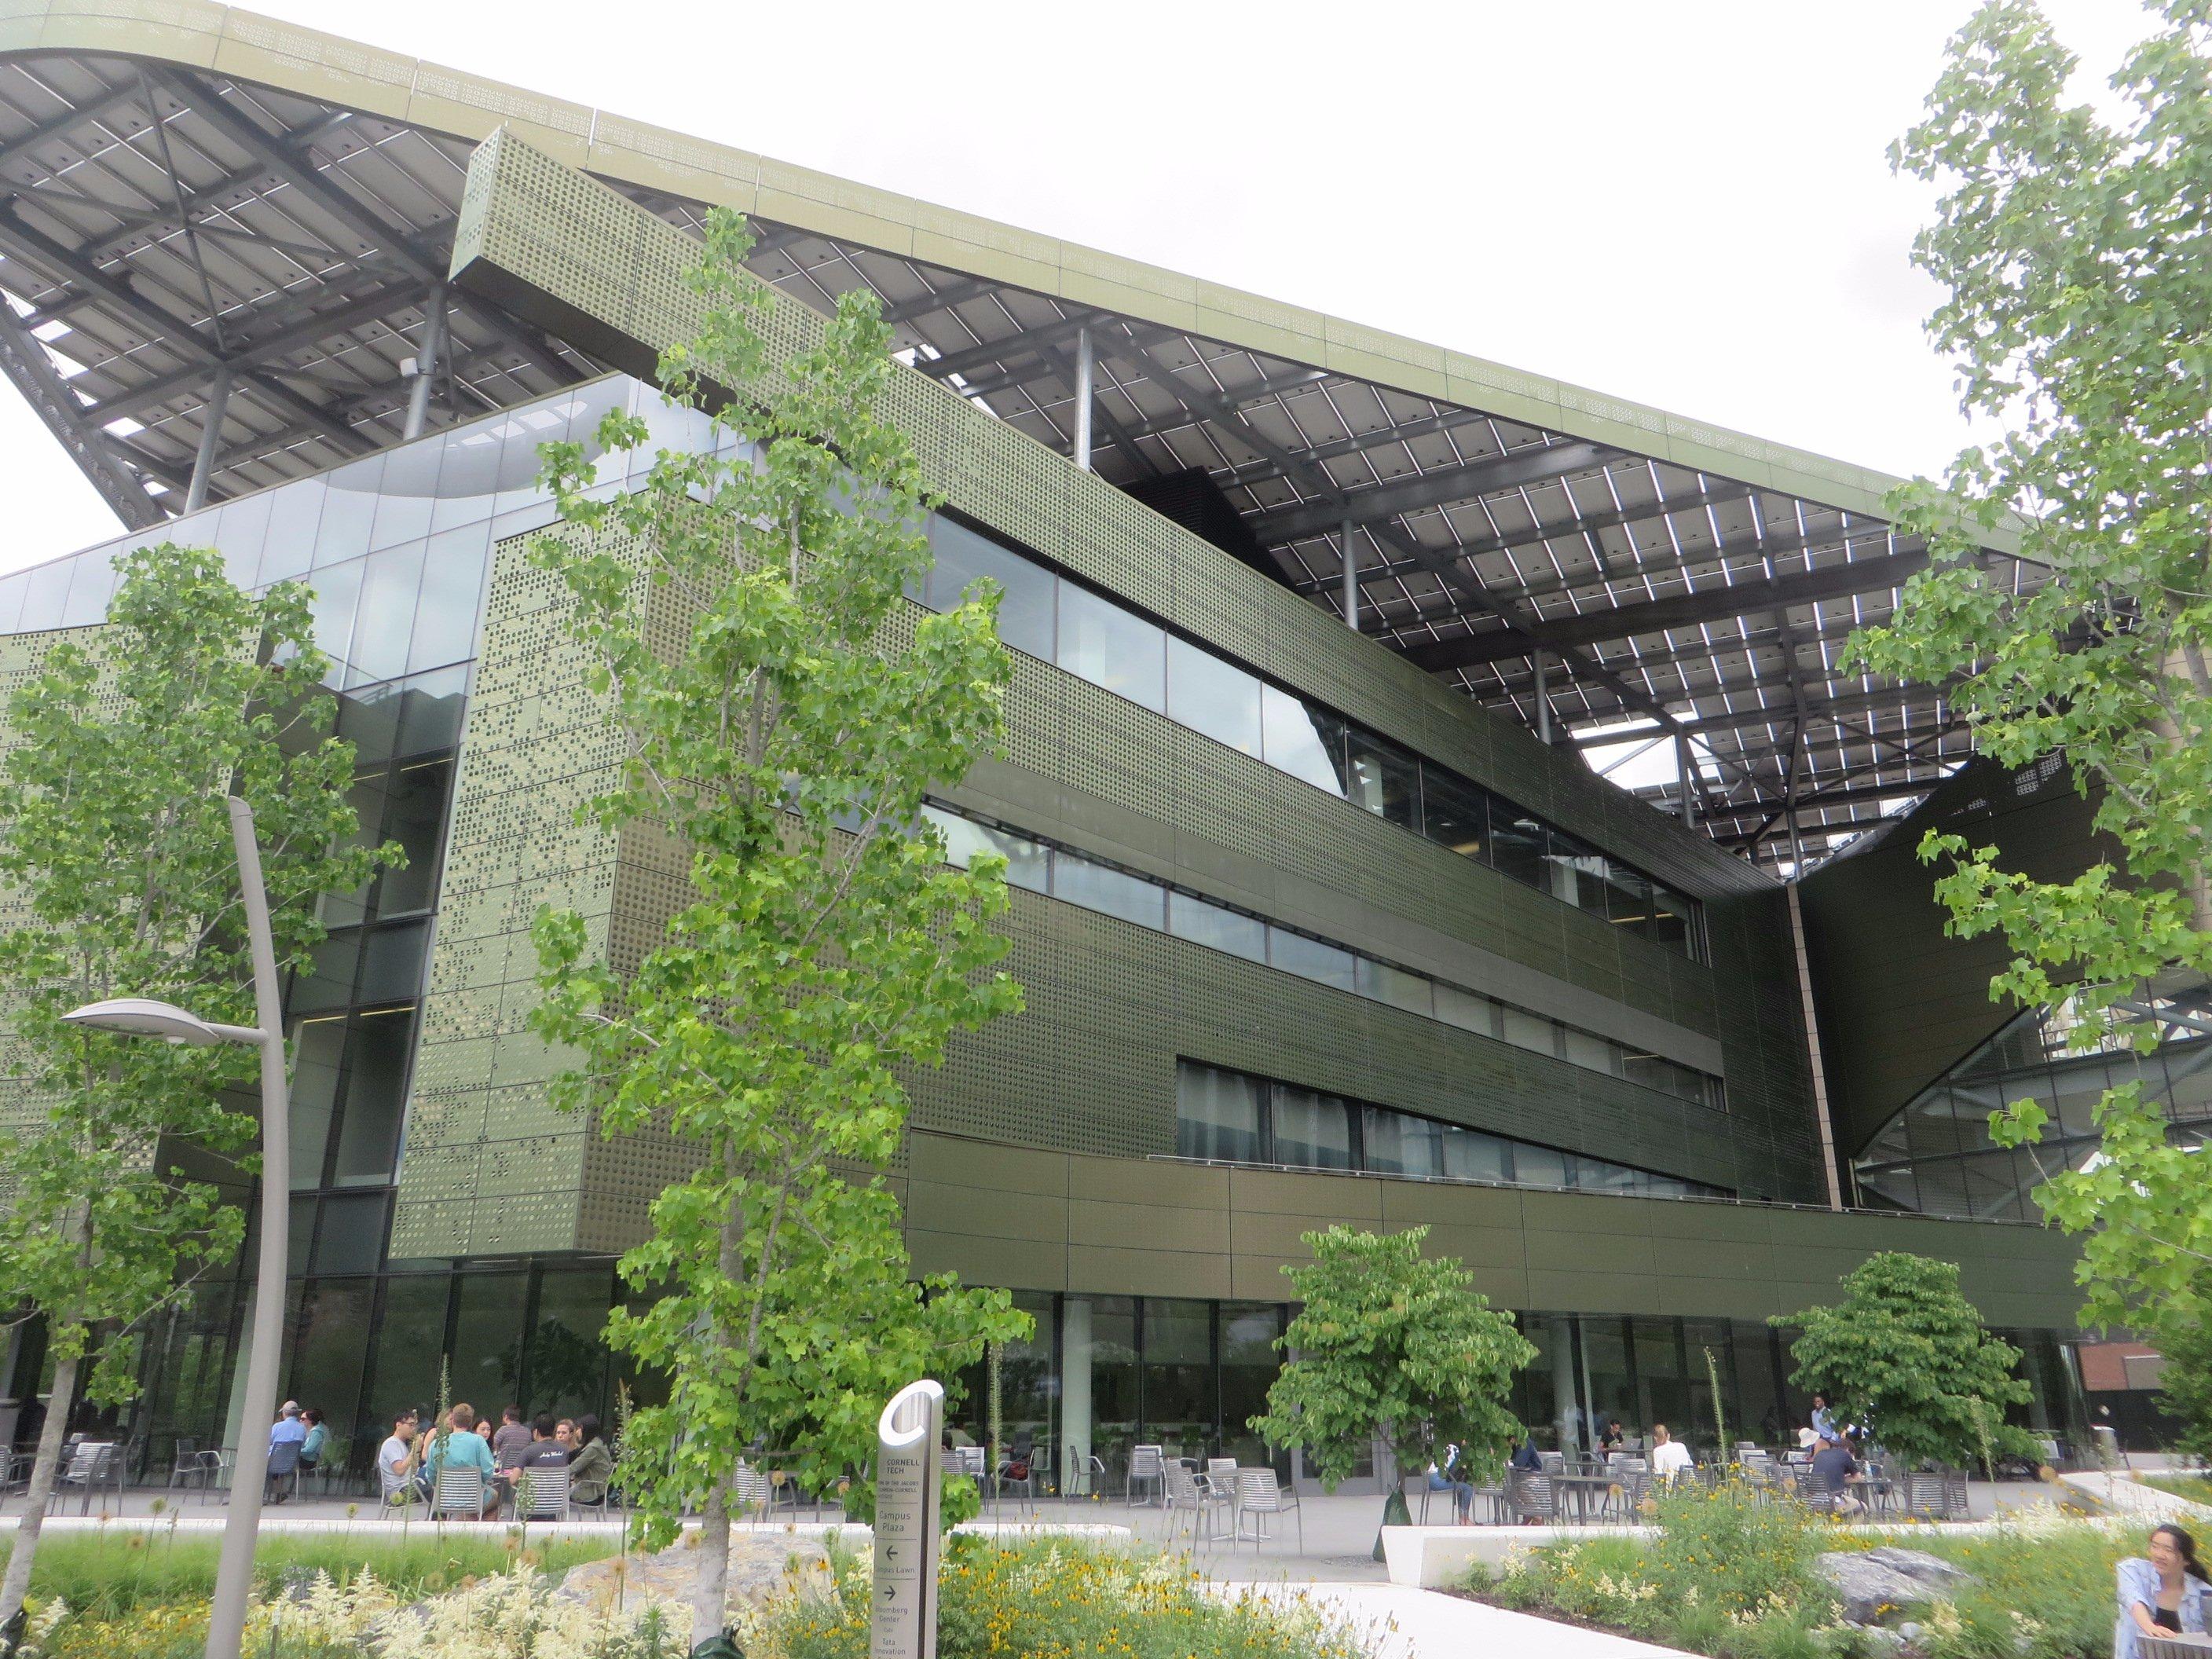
[{"x1": 0, "y1": 0, "x2": 2148, "y2": 569}]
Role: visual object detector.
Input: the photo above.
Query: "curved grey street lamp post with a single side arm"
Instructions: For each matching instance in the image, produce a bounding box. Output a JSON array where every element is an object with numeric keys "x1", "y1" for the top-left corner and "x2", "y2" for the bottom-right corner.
[{"x1": 62, "y1": 797, "x2": 292, "y2": 1659}]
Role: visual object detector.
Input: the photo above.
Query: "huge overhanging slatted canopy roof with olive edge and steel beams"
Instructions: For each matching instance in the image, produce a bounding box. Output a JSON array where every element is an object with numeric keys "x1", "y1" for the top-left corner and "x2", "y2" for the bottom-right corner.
[{"x1": 0, "y1": 0, "x2": 2009, "y2": 876}]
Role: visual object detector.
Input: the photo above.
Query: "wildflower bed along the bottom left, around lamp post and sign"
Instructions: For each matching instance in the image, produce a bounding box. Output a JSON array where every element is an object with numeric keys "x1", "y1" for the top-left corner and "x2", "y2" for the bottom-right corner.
[{"x1": 9, "y1": 1535, "x2": 1364, "y2": 1659}]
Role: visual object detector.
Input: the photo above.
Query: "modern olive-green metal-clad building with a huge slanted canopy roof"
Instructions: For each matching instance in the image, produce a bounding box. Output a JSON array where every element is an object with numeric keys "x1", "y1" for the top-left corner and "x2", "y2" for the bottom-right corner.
[{"x1": 0, "y1": 0, "x2": 2206, "y2": 1495}]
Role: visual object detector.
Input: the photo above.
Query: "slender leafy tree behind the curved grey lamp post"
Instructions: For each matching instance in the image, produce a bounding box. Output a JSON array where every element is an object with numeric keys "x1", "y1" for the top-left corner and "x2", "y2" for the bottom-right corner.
[{"x1": 0, "y1": 544, "x2": 398, "y2": 1624}]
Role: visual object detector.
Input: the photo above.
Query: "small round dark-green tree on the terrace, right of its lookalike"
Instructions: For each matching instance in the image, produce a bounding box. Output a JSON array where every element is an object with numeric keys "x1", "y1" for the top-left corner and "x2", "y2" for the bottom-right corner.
[{"x1": 1770, "y1": 1250, "x2": 2038, "y2": 1469}]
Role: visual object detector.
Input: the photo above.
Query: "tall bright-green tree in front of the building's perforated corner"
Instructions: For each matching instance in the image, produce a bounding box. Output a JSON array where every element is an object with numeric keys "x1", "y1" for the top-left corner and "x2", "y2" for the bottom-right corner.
[{"x1": 533, "y1": 214, "x2": 1031, "y2": 1641}]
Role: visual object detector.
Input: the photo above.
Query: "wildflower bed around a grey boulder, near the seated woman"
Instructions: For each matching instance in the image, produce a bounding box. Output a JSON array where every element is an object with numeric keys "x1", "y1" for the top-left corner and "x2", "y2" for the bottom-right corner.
[{"x1": 1462, "y1": 1486, "x2": 2144, "y2": 1659}]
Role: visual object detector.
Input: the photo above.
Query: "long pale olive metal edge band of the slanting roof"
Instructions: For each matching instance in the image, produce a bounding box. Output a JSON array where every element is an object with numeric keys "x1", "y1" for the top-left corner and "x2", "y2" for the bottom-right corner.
[{"x1": 0, "y1": 0, "x2": 2017, "y2": 553}]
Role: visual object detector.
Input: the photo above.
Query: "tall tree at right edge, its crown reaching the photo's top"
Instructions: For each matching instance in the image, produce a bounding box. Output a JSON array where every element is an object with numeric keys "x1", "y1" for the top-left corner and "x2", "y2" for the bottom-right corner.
[{"x1": 1854, "y1": 0, "x2": 2212, "y2": 1353}]
